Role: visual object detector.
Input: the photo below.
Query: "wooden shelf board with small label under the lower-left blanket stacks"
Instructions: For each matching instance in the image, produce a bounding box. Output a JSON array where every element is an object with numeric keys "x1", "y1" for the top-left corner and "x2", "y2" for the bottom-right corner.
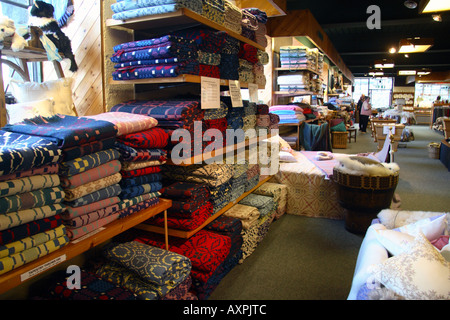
[{"x1": 0, "y1": 199, "x2": 172, "y2": 293}]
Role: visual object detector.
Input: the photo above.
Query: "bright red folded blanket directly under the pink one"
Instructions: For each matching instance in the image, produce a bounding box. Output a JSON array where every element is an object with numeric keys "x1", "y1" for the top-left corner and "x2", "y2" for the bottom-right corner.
[{"x1": 117, "y1": 127, "x2": 169, "y2": 149}]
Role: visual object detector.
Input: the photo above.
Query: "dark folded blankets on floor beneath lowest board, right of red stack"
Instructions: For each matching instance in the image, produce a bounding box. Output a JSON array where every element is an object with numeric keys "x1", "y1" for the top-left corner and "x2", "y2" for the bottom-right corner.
[{"x1": 193, "y1": 216, "x2": 243, "y2": 300}]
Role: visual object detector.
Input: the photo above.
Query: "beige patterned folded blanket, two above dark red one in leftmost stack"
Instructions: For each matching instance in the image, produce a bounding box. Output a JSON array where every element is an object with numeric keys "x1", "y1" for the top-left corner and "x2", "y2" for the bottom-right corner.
[{"x1": 0, "y1": 186, "x2": 65, "y2": 213}]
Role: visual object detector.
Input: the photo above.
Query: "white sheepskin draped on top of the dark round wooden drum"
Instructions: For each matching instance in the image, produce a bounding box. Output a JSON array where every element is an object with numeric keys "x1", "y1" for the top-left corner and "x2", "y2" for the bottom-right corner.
[{"x1": 337, "y1": 157, "x2": 400, "y2": 176}]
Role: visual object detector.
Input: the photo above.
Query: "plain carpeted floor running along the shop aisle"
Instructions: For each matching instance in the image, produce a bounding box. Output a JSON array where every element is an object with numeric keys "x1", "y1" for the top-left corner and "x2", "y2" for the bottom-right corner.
[{"x1": 209, "y1": 125, "x2": 450, "y2": 300}]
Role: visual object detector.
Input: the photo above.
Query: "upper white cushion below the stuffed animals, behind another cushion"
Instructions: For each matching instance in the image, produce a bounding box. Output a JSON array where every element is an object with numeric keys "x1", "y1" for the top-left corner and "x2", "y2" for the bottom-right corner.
[{"x1": 10, "y1": 78, "x2": 76, "y2": 116}]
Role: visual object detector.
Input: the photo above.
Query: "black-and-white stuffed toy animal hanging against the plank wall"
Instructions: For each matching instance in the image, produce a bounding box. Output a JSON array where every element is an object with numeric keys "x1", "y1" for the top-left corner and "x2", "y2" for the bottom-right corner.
[{"x1": 28, "y1": 1, "x2": 78, "y2": 72}]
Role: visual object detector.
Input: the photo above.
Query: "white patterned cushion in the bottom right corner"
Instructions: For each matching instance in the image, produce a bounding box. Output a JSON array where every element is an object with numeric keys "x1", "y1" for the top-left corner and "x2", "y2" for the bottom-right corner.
[{"x1": 370, "y1": 233, "x2": 450, "y2": 300}]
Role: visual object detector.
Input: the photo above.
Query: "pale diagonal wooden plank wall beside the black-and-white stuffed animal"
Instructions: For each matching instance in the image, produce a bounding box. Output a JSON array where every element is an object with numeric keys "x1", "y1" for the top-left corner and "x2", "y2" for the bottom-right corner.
[{"x1": 43, "y1": 0, "x2": 104, "y2": 116}]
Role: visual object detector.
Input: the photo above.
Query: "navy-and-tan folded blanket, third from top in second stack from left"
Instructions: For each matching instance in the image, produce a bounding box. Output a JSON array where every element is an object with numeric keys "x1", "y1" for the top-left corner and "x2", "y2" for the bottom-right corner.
[{"x1": 59, "y1": 149, "x2": 120, "y2": 176}]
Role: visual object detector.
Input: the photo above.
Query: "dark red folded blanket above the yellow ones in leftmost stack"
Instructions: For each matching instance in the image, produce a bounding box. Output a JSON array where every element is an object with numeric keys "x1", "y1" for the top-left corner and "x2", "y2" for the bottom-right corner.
[{"x1": 0, "y1": 214, "x2": 62, "y2": 245}]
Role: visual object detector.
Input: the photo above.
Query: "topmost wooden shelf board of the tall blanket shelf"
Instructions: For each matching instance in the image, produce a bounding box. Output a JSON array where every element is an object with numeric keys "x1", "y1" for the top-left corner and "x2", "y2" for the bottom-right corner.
[{"x1": 106, "y1": 8, "x2": 265, "y2": 51}]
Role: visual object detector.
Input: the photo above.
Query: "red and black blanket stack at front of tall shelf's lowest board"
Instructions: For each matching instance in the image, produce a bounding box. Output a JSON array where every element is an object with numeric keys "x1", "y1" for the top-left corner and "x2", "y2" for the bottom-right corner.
[{"x1": 145, "y1": 182, "x2": 213, "y2": 231}]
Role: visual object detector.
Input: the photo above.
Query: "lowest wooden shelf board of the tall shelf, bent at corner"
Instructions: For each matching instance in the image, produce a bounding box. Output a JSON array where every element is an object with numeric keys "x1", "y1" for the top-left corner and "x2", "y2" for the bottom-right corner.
[{"x1": 135, "y1": 176, "x2": 271, "y2": 239}]
